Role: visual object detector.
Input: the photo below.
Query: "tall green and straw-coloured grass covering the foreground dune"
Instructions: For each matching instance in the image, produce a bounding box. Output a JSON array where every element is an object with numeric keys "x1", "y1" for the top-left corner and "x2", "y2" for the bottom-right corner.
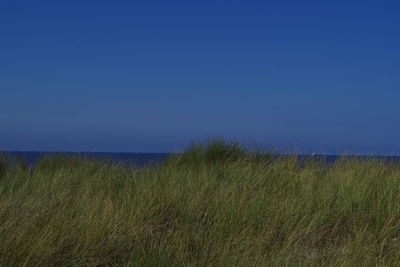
[{"x1": 0, "y1": 140, "x2": 400, "y2": 266}]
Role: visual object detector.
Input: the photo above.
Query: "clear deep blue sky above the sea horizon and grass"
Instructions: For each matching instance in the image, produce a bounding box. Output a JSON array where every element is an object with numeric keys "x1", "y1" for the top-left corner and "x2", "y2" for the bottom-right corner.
[{"x1": 0, "y1": 0, "x2": 400, "y2": 155}]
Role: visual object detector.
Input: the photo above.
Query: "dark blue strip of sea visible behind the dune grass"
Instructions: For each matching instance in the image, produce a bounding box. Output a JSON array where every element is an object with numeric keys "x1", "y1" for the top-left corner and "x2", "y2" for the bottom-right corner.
[{"x1": 6, "y1": 151, "x2": 400, "y2": 166}]
